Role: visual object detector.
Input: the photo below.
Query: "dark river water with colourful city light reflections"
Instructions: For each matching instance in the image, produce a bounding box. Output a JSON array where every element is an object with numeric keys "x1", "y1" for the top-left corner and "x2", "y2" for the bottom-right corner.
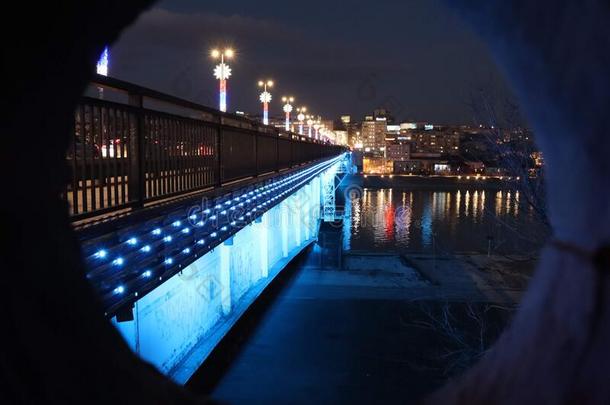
[{"x1": 343, "y1": 189, "x2": 546, "y2": 253}]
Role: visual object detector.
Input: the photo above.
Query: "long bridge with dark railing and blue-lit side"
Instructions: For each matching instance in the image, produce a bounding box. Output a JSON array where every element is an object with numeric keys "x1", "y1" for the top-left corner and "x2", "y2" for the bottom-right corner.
[{"x1": 64, "y1": 76, "x2": 351, "y2": 383}]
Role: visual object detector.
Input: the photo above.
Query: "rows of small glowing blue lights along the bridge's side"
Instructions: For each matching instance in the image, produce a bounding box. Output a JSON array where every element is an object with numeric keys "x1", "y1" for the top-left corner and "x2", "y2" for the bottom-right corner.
[{"x1": 86, "y1": 155, "x2": 343, "y2": 315}]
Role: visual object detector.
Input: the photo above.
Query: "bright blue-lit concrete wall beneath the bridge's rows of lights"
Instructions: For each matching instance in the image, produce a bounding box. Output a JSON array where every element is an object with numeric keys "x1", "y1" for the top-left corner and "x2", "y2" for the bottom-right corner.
[{"x1": 112, "y1": 176, "x2": 322, "y2": 383}]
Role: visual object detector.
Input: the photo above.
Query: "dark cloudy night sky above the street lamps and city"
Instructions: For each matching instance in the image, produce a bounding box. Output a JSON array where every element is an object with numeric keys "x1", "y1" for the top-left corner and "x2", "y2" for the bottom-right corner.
[{"x1": 110, "y1": 0, "x2": 508, "y2": 124}]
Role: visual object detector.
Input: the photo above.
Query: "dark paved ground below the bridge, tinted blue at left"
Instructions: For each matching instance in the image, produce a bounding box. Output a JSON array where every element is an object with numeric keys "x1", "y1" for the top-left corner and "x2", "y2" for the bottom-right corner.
[{"x1": 188, "y1": 229, "x2": 533, "y2": 404}]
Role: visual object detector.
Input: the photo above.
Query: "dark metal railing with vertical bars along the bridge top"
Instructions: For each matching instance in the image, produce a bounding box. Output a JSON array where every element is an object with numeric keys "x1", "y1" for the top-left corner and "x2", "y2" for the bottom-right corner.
[{"x1": 64, "y1": 76, "x2": 342, "y2": 220}]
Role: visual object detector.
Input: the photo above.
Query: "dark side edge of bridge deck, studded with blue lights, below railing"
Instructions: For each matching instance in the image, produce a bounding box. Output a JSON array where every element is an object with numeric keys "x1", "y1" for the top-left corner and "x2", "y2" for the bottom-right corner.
[{"x1": 81, "y1": 158, "x2": 338, "y2": 320}]
